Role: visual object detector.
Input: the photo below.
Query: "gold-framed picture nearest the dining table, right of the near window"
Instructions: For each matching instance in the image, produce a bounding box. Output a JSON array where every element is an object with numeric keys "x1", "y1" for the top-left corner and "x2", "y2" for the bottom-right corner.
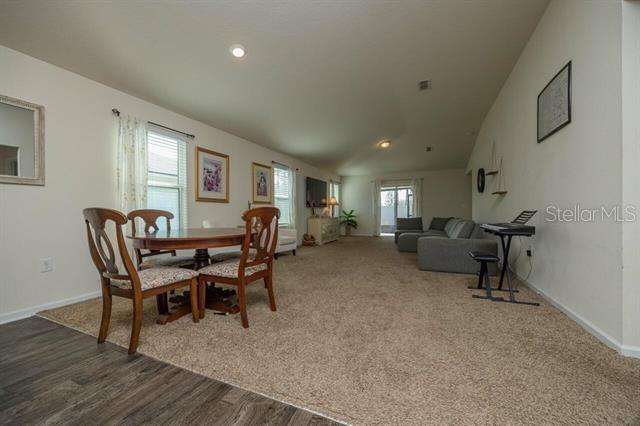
[{"x1": 196, "y1": 147, "x2": 230, "y2": 203}]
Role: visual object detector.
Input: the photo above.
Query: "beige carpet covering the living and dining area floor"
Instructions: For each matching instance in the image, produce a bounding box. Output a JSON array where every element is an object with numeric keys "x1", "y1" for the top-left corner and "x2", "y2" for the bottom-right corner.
[{"x1": 42, "y1": 237, "x2": 640, "y2": 425}]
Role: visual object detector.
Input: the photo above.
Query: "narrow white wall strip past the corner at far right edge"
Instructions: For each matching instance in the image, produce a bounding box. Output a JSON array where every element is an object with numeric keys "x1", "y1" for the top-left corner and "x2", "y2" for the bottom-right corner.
[{"x1": 622, "y1": 1, "x2": 640, "y2": 357}]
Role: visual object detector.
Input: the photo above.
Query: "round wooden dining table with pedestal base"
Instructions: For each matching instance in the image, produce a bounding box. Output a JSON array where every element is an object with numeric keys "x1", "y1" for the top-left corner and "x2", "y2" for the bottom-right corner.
[{"x1": 128, "y1": 227, "x2": 245, "y2": 324}]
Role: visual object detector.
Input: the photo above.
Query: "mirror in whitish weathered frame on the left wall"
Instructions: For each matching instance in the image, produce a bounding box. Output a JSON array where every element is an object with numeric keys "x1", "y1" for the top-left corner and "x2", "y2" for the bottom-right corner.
[{"x1": 0, "y1": 95, "x2": 44, "y2": 185}]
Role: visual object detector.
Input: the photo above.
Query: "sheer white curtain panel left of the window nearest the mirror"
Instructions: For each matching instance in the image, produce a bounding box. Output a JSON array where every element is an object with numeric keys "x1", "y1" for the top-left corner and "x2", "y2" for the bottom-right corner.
[{"x1": 117, "y1": 116, "x2": 148, "y2": 214}]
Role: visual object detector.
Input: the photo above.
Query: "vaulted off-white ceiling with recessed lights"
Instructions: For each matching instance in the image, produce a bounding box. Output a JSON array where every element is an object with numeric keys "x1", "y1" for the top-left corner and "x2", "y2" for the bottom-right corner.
[{"x1": 0, "y1": 0, "x2": 548, "y2": 175}]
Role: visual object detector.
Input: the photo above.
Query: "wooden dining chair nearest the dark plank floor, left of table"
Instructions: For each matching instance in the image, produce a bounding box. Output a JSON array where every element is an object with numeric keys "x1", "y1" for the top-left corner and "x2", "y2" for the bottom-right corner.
[{"x1": 82, "y1": 208, "x2": 199, "y2": 354}]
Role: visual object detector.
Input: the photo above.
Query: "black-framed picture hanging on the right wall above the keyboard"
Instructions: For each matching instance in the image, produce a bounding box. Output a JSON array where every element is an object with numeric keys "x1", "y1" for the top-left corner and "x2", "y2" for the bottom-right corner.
[{"x1": 538, "y1": 61, "x2": 571, "y2": 143}]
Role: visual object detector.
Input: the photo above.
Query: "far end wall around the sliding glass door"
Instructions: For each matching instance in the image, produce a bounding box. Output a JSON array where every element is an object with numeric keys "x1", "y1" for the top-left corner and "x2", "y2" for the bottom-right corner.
[{"x1": 341, "y1": 169, "x2": 471, "y2": 235}]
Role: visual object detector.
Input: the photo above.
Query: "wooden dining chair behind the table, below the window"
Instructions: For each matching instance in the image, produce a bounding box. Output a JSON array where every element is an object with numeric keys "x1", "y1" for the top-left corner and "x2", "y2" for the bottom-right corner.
[{"x1": 127, "y1": 209, "x2": 195, "y2": 270}]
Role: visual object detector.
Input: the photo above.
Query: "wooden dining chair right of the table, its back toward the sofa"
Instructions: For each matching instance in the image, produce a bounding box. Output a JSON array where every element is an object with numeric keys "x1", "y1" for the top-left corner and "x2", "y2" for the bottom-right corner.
[{"x1": 198, "y1": 207, "x2": 280, "y2": 328}]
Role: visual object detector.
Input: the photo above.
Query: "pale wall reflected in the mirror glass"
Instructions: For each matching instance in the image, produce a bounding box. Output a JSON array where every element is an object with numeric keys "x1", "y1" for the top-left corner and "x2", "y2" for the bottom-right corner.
[{"x1": 0, "y1": 104, "x2": 36, "y2": 177}]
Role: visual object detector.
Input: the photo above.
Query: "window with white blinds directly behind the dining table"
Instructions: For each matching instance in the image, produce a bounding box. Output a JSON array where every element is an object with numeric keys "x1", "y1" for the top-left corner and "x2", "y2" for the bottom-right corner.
[{"x1": 147, "y1": 127, "x2": 187, "y2": 229}]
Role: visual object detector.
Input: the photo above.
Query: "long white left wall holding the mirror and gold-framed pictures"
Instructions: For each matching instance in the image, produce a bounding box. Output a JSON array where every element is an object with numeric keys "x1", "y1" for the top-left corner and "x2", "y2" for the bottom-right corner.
[{"x1": 0, "y1": 46, "x2": 339, "y2": 320}]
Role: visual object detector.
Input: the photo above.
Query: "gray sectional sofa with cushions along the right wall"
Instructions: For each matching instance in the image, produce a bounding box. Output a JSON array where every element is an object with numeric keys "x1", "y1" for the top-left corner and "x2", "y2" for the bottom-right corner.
[{"x1": 396, "y1": 218, "x2": 498, "y2": 275}]
